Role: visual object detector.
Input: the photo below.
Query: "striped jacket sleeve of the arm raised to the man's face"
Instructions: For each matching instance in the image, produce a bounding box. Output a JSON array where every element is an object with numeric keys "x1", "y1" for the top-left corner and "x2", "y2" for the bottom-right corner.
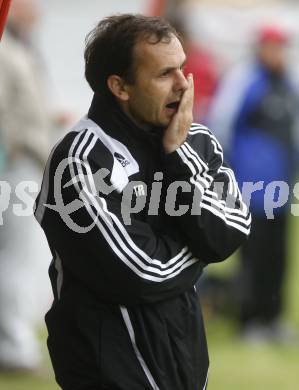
[{"x1": 165, "y1": 124, "x2": 251, "y2": 263}]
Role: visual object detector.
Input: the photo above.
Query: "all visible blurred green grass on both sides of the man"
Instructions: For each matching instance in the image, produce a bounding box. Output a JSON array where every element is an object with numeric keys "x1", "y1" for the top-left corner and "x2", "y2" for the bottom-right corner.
[{"x1": 0, "y1": 217, "x2": 299, "y2": 390}]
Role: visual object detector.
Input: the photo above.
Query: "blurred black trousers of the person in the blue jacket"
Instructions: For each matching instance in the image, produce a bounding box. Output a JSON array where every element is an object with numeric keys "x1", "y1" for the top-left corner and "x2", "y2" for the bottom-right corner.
[{"x1": 240, "y1": 212, "x2": 287, "y2": 326}]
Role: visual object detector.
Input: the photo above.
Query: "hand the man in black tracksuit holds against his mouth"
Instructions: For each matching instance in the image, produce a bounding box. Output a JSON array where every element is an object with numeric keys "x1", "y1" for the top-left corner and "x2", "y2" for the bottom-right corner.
[{"x1": 163, "y1": 74, "x2": 194, "y2": 154}]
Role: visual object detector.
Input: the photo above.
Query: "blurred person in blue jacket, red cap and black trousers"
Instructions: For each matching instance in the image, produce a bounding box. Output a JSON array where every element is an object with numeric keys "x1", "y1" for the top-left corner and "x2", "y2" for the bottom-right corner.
[{"x1": 209, "y1": 25, "x2": 299, "y2": 342}]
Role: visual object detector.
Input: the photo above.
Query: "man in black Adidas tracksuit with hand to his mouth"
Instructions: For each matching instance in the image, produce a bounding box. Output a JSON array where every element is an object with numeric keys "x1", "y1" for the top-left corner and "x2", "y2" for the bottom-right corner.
[{"x1": 36, "y1": 15, "x2": 250, "y2": 390}]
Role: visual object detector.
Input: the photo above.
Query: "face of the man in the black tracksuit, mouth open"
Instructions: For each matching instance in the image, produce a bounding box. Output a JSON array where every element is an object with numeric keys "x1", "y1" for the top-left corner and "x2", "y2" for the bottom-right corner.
[{"x1": 123, "y1": 35, "x2": 188, "y2": 127}]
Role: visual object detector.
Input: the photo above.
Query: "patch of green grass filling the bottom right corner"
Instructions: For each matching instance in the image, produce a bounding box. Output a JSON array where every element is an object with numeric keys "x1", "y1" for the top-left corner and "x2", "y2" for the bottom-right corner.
[{"x1": 208, "y1": 320, "x2": 299, "y2": 390}]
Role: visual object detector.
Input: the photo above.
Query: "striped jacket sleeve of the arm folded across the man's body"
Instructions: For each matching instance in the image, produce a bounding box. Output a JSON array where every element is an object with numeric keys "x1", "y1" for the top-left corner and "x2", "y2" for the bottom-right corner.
[{"x1": 35, "y1": 132, "x2": 204, "y2": 305}]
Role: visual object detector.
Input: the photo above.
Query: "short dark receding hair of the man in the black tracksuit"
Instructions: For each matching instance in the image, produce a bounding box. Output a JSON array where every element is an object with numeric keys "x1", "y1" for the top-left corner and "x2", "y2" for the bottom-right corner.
[{"x1": 84, "y1": 14, "x2": 180, "y2": 96}]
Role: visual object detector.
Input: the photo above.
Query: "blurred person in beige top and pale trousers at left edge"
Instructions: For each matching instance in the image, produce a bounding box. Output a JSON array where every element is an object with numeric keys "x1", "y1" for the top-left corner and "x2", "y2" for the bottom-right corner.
[{"x1": 0, "y1": 0, "x2": 68, "y2": 371}]
